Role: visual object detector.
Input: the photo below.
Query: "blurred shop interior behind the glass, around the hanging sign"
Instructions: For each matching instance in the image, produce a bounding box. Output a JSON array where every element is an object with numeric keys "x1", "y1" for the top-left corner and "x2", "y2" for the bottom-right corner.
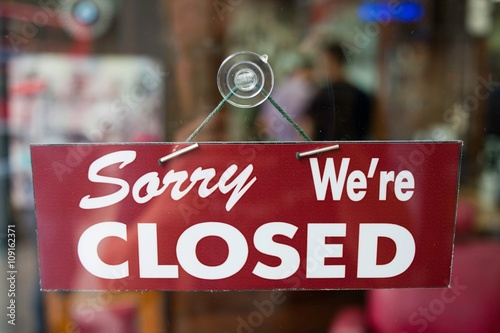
[{"x1": 0, "y1": 0, "x2": 500, "y2": 333}]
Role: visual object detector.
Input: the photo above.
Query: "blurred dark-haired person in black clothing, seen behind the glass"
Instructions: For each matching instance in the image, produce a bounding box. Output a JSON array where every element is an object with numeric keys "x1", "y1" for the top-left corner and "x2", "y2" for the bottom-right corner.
[{"x1": 302, "y1": 44, "x2": 373, "y2": 141}]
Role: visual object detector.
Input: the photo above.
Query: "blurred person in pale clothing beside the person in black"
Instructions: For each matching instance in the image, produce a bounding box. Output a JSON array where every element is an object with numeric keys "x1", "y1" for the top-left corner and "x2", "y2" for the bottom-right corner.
[{"x1": 258, "y1": 55, "x2": 316, "y2": 141}]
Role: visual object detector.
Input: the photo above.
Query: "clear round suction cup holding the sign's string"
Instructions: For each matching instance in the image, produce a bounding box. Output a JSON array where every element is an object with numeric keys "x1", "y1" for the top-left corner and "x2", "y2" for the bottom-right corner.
[{"x1": 217, "y1": 51, "x2": 274, "y2": 108}]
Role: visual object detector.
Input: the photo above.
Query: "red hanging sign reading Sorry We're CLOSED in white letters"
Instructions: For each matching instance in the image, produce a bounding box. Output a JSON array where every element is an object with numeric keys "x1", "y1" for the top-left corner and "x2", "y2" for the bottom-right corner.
[{"x1": 31, "y1": 141, "x2": 461, "y2": 290}]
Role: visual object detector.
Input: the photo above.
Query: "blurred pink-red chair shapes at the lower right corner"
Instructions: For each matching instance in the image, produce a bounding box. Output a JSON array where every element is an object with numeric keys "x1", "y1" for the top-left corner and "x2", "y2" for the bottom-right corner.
[{"x1": 367, "y1": 200, "x2": 500, "y2": 333}]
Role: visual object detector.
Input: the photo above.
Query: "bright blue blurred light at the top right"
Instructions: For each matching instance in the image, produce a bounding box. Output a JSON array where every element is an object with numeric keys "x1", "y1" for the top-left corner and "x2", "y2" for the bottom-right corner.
[{"x1": 358, "y1": 1, "x2": 424, "y2": 23}]
